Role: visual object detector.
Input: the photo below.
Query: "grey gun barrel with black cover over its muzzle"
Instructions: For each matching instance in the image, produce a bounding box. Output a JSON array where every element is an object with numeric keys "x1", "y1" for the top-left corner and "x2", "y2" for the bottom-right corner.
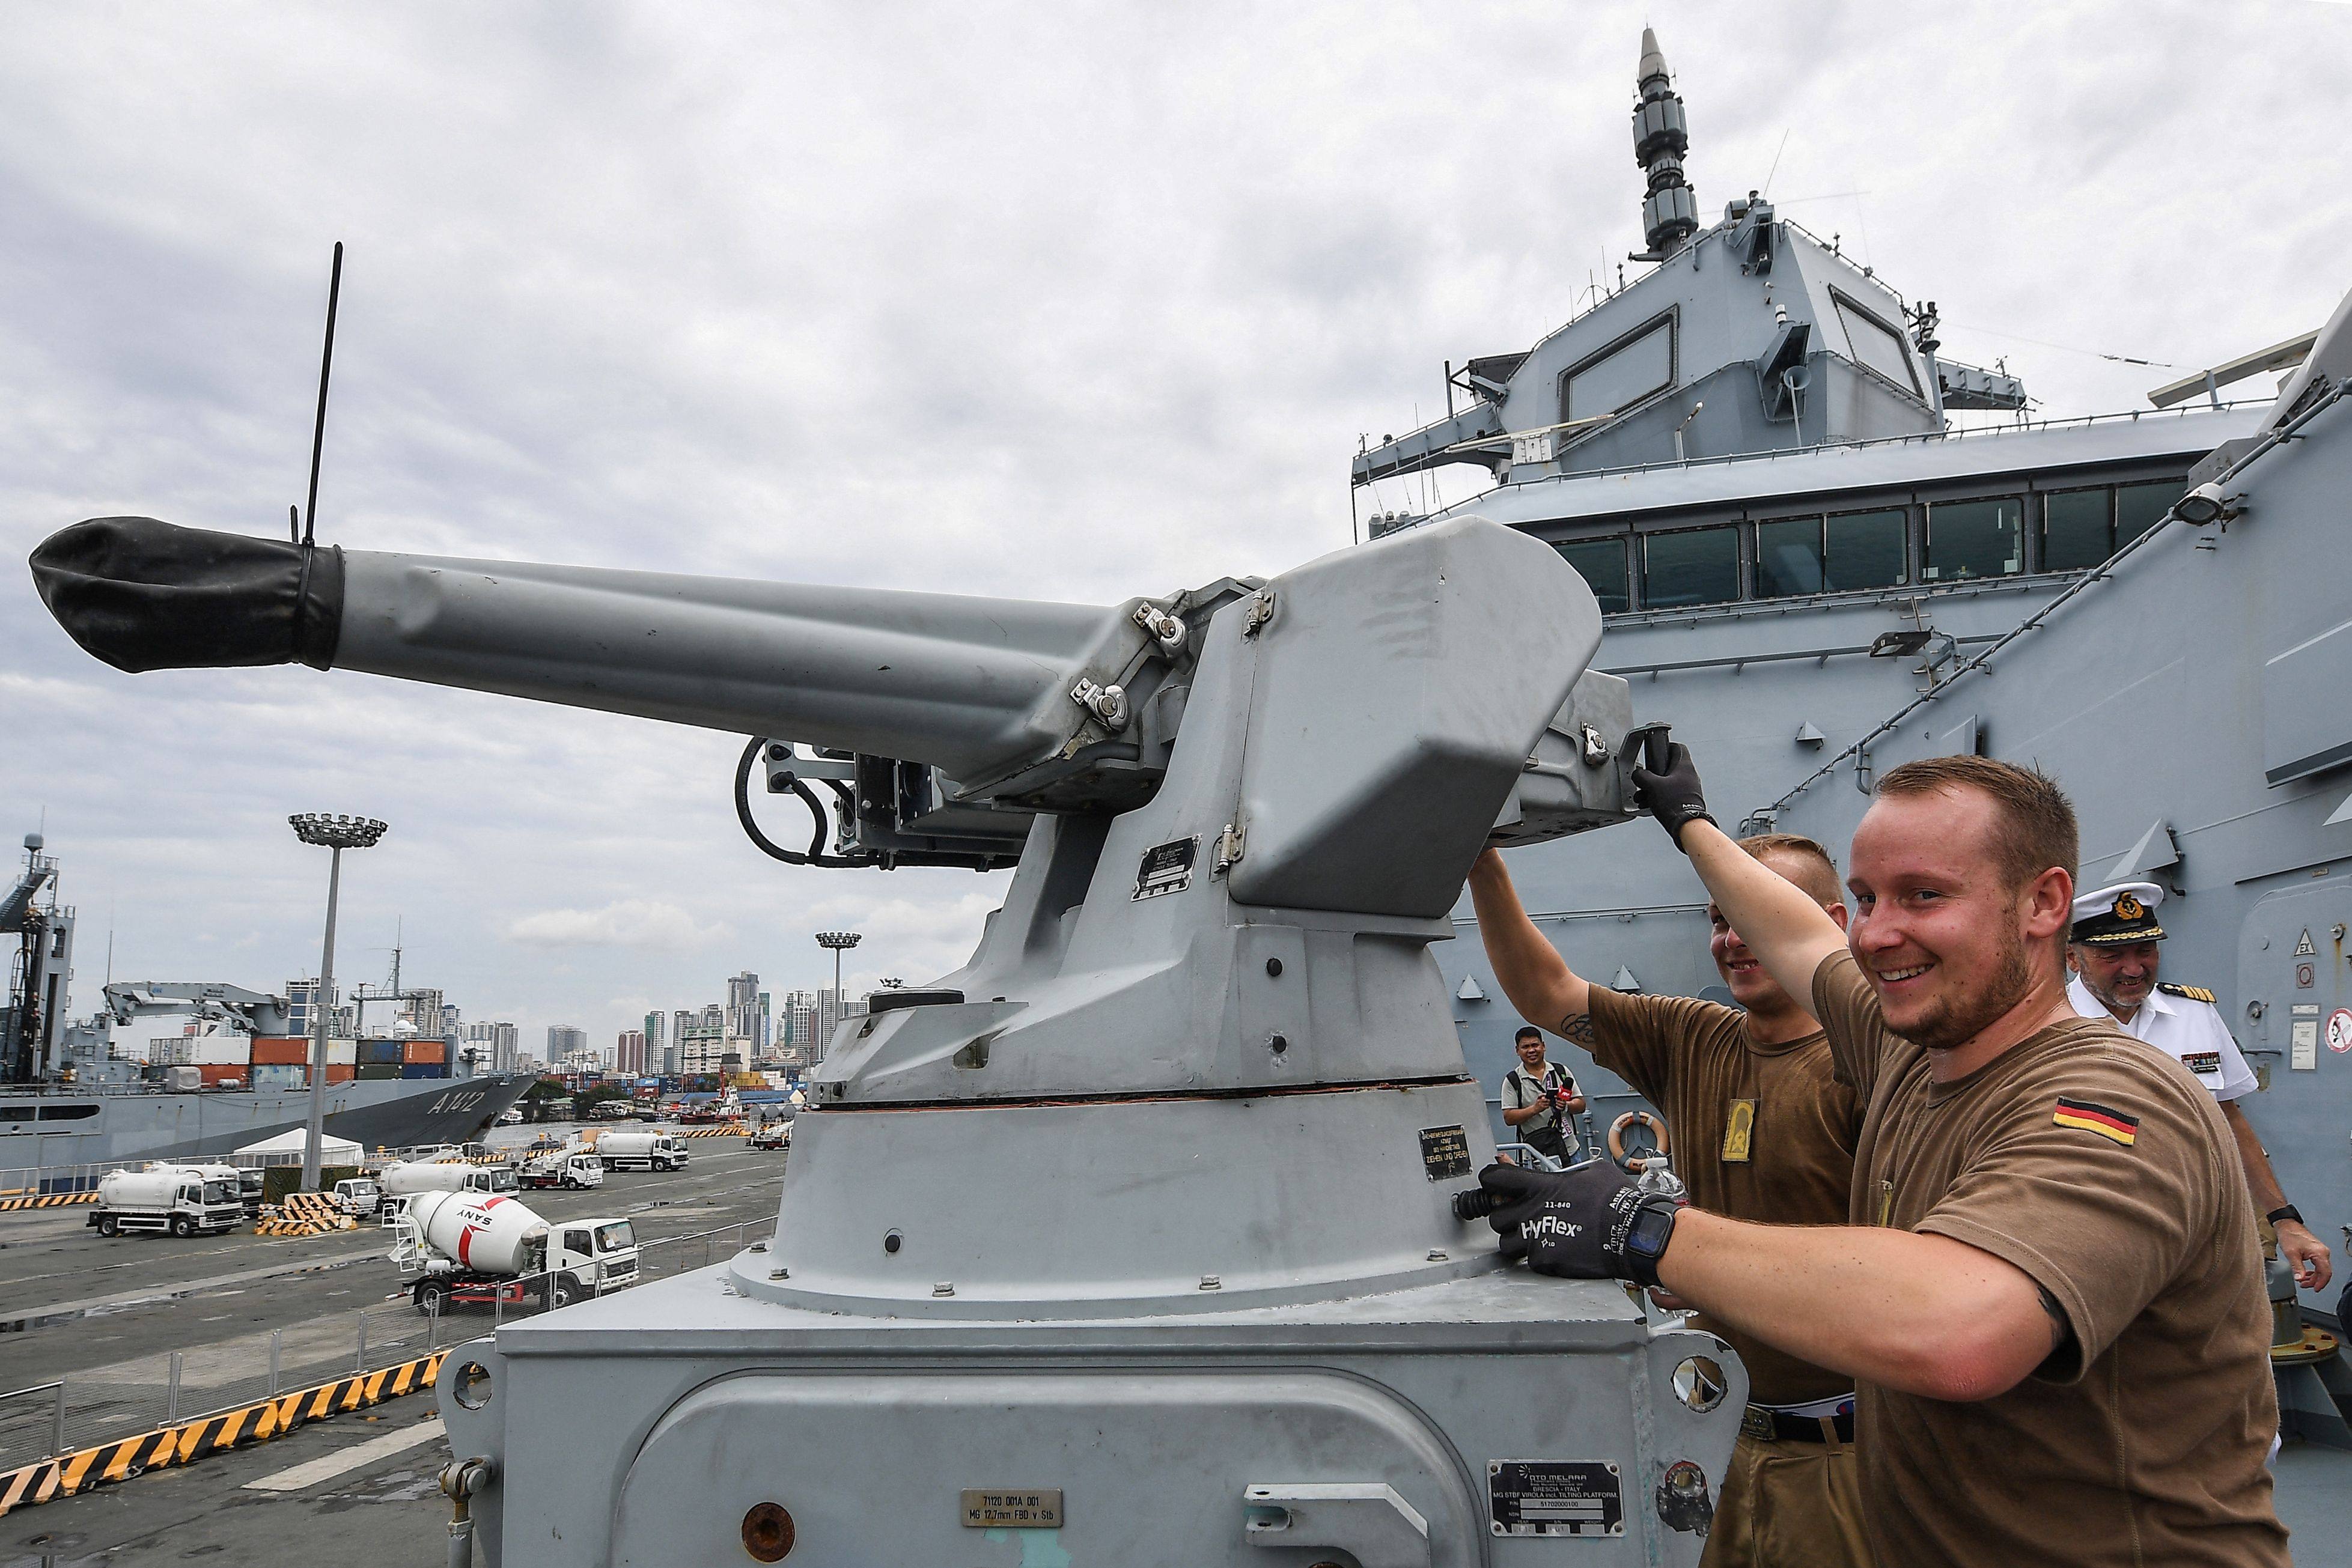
[{"x1": 33, "y1": 517, "x2": 1120, "y2": 778}]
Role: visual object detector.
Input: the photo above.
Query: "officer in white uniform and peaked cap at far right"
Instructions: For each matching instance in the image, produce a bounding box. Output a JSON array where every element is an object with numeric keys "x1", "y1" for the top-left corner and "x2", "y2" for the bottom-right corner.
[{"x1": 2065, "y1": 881, "x2": 2336, "y2": 1290}]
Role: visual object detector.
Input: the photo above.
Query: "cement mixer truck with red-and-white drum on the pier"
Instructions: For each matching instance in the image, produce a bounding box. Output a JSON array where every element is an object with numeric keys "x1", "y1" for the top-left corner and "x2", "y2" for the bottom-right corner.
[{"x1": 393, "y1": 1192, "x2": 638, "y2": 1311}]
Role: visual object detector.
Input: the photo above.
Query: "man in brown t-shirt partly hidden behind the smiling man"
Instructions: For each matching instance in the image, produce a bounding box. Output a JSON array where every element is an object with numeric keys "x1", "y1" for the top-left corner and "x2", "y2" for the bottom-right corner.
[{"x1": 1470, "y1": 860, "x2": 1870, "y2": 1568}]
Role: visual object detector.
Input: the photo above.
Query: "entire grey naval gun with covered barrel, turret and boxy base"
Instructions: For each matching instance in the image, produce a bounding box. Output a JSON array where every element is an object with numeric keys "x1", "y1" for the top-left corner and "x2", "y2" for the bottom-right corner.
[{"x1": 33, "y1": 517, "x2": 1745, "y2": 1568}]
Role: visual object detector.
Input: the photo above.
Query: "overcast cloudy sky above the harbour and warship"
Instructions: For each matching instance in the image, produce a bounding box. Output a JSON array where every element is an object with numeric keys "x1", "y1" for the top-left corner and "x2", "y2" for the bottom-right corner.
[{"x1": 0, "y1": 0, "x2": 2352, "y2": 1062}]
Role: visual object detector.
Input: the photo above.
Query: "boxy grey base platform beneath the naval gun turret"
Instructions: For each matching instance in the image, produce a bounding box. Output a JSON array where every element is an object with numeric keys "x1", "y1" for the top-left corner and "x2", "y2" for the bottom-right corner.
[{"x1": 442, "y1": 1251, "x2": 1747, "y2": 1568}]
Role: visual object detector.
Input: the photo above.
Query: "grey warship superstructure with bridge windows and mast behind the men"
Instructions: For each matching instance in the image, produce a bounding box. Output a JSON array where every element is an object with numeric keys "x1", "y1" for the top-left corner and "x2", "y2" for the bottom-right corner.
[{"x1": 1350, "y1": 33, "x2": 2352, "y2": 1444}]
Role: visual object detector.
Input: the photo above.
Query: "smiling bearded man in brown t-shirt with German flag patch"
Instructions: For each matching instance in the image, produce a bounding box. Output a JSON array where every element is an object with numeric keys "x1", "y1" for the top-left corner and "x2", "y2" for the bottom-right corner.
[{"x1": 1479, "y1": 745, "x2": 2288, "y2": 1568}]
